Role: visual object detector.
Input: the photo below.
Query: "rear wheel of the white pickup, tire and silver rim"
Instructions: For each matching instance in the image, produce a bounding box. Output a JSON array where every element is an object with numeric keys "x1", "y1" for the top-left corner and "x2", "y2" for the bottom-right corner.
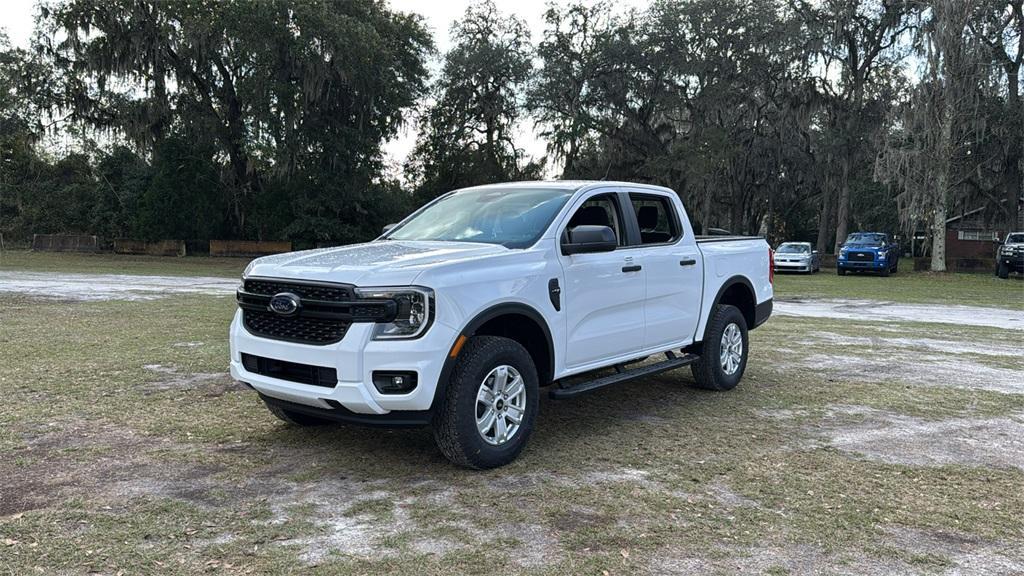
[{"x1": 690, "y1": 305, "x2": 749, "y2": 390}]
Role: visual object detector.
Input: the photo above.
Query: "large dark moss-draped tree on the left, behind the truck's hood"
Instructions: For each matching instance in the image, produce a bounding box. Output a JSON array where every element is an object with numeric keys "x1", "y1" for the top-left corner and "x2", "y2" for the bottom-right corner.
[{"x1": 40, "y1": 0, "x2": 431, "y2": 241}]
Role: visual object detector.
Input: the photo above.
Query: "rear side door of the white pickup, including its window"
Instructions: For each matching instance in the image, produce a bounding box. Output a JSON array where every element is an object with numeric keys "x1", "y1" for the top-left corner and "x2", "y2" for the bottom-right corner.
[{"x1": 629, "y1": 192, "x2": 705, "y2": 349}]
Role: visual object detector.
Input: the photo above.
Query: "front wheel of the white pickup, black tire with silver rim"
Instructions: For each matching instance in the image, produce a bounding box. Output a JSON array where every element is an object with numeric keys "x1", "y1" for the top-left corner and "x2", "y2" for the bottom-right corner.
[{"x1": 434, "y1": 336, "x2": 540, "y2": 469}]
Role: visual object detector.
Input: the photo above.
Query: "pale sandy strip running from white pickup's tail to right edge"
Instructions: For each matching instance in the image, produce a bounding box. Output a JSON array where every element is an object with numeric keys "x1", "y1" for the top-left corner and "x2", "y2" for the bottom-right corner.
[{"x1": 772, "y1": 298, "x2": 1024, "y2": 330}]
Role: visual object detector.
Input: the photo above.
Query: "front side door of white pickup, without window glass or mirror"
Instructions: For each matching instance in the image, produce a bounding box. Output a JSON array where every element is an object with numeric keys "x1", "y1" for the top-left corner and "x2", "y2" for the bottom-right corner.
[{"x1": 558, "y1": 191, "x2": 645, "y2": 369}]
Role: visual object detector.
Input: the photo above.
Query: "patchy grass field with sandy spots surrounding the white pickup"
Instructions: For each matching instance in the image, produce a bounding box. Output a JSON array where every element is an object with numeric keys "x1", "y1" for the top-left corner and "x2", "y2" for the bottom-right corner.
[{"x1": 0, "y1": 253, "x2": 1024, "y2": 575}]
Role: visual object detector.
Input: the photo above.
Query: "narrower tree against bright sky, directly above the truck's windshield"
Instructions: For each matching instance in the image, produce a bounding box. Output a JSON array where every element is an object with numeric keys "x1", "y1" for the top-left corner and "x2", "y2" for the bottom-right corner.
[{"x1": 408, "y1": 0, "x2": 541, "y2": 201}]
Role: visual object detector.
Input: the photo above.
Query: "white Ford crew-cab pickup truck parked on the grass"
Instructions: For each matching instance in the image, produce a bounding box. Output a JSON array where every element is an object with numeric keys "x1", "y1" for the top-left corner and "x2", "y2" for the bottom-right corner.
[{"x1": 230, "y1": 181, "x2": 772, "y2": 468}]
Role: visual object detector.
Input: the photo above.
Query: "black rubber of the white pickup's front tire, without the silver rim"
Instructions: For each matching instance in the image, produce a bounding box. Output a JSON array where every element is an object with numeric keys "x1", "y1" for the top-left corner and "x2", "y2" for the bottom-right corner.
[{"x1": 433, "y1": 336, "x2": 540, "y2": 469}]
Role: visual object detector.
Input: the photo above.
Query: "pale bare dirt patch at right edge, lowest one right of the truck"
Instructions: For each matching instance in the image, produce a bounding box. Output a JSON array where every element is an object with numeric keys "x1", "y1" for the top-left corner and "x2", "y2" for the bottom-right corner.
[{"x1": 810, "y1": 407, "x2": 1024, "y2": 470}]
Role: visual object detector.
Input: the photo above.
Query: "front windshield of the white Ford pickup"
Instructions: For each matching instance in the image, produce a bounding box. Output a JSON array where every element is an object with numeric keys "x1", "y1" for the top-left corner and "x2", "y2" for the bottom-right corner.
[{"x1": 385, "y1": 187, "x2": 573, "y2": 248}]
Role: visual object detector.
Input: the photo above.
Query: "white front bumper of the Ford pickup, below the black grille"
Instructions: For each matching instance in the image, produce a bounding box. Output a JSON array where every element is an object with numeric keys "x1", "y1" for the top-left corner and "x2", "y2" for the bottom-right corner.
[{"x1": 230, "y1": 311, "x2": 458, "y2": 412}]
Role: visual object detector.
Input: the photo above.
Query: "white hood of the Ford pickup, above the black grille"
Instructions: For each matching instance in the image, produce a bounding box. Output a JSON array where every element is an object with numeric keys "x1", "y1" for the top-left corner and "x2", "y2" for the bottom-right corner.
[{"x1": 248, "y1": 240, "x2": 509, "y2": 286}]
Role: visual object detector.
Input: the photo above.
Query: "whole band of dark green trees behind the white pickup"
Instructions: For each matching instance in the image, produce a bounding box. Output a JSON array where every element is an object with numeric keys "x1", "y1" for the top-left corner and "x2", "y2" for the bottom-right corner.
[{"x1": 0, "y1": 0, "x2": 1024, "y2": 249}]
